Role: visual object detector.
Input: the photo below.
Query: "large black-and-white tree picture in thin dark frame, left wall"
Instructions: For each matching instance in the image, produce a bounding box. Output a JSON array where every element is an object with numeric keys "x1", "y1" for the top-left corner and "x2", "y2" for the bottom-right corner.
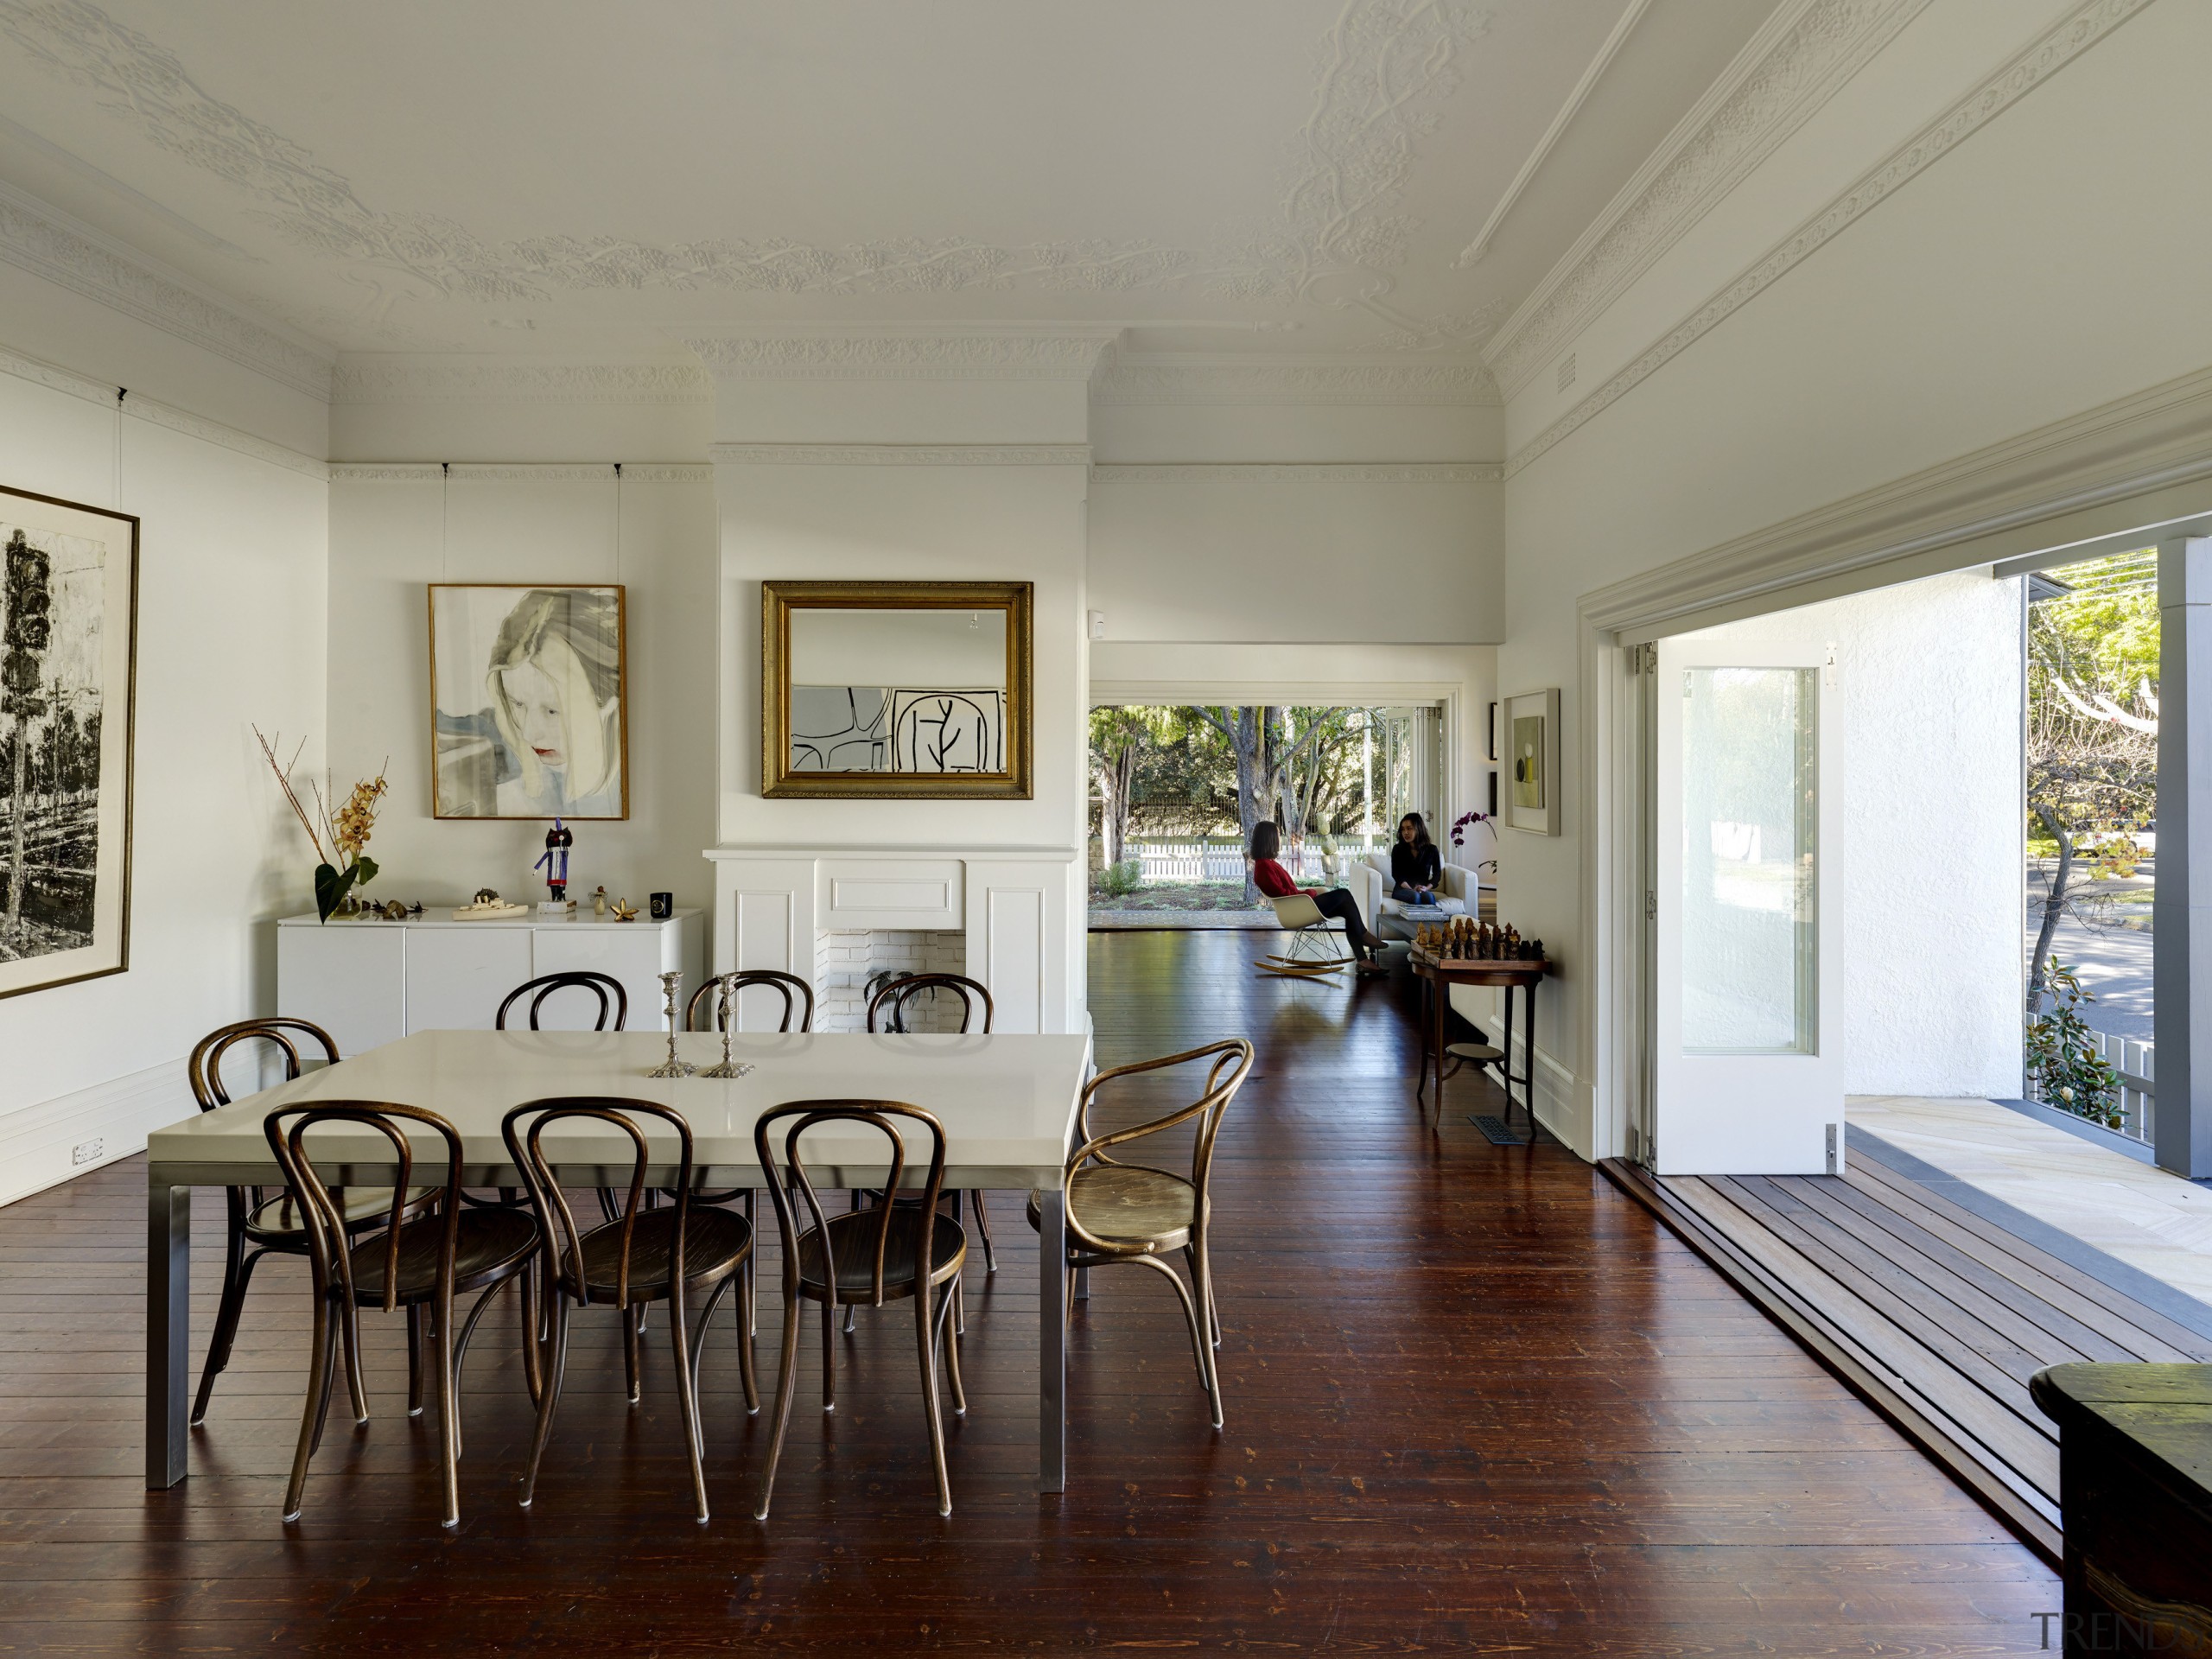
[{"x1": 0, "y1": 486, "x2": 139, "y2": 998}]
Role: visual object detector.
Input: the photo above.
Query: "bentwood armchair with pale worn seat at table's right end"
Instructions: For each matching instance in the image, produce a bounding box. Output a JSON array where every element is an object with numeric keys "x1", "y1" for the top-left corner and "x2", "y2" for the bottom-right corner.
[{"x1": 1028, "y1": 1038, "x2": 1252, "y2": 1429}]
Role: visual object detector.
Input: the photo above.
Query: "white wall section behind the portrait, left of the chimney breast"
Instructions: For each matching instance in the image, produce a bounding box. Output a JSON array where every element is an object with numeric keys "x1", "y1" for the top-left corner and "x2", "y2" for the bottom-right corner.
[{"x1": 329, "y1": 462, "x2": 715, "y2": 907}]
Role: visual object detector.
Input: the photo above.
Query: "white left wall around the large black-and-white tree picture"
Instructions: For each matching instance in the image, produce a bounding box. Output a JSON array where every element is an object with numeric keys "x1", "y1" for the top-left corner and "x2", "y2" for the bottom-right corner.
[{"x1": 0, "y1": 334, "x2": 327, "y2": 1201}]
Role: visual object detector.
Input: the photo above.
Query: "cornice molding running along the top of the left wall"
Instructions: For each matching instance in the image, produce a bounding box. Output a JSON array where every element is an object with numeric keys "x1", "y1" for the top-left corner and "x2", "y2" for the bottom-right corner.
[{"x1": 0, "y1": 183, "x2": 329, "y2": 403}]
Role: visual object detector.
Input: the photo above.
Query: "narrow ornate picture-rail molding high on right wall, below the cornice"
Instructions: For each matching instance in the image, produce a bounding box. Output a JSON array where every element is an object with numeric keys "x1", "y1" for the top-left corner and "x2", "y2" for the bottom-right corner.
[{"x1": 1506, "y1": 0, "x2": 2150, "y2": 478}]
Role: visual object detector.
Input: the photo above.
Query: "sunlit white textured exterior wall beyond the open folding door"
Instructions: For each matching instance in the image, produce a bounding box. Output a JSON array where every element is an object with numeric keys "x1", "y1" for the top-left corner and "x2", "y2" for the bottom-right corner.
[{"x1": 1662, "y1": 569, "x2": 2026, "y2": 1097}]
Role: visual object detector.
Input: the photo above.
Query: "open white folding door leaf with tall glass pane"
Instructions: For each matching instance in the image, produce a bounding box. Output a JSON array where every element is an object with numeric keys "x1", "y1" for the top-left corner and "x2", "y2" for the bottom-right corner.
[{"x1": 1652, "y1": 637, "x2": 1842, "y2": 1174}]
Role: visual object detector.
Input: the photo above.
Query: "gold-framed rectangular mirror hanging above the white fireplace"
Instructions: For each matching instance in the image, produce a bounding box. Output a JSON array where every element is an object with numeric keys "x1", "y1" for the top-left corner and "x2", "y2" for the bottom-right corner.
[{"x1": 761, "y1": 582, "x2": 1033, "y2": 801}]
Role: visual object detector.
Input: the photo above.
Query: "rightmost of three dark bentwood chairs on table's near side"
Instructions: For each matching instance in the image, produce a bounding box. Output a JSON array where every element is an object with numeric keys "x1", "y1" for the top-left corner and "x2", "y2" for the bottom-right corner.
[{"x1": 752, "y1": 1099, "x2": 967, "y2": 1520}]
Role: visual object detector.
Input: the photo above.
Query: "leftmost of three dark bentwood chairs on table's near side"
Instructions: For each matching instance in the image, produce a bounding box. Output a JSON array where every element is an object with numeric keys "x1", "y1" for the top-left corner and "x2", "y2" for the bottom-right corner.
[{"x1": 261, "y1": 1099, "x2": 542, "y2": 1526}]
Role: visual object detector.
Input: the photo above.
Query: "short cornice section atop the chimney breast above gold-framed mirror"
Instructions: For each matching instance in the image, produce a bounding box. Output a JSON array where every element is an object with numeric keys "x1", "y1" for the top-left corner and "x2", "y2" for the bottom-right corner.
[{"x1": 683, "y1": 329, "x2": 1119, "y2": 380}]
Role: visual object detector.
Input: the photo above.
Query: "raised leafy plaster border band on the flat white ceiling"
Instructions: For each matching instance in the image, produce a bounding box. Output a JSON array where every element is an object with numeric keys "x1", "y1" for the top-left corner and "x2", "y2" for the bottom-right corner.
[{"x1": 0, "y1": 0, "x2": 1496, "y2": 349}]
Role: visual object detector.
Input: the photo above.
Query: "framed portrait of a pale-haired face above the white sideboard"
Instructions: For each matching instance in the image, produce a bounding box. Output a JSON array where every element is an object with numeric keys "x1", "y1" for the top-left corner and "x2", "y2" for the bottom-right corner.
[{"x1": 429, "y1": 582, "x2": 631, "y2": 818}]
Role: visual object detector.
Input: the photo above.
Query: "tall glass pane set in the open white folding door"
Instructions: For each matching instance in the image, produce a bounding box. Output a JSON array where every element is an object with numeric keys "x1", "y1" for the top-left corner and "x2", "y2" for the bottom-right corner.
[{"x1": 1681, "y1": 668, "x2": 1821, "y2": 1055}]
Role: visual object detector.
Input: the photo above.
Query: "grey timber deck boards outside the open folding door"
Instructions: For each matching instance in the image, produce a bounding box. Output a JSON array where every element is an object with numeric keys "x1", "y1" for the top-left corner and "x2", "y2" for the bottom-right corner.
[{"x1": 1606, "y1": 1159, "x2": 2212, "y2": 1555}]
